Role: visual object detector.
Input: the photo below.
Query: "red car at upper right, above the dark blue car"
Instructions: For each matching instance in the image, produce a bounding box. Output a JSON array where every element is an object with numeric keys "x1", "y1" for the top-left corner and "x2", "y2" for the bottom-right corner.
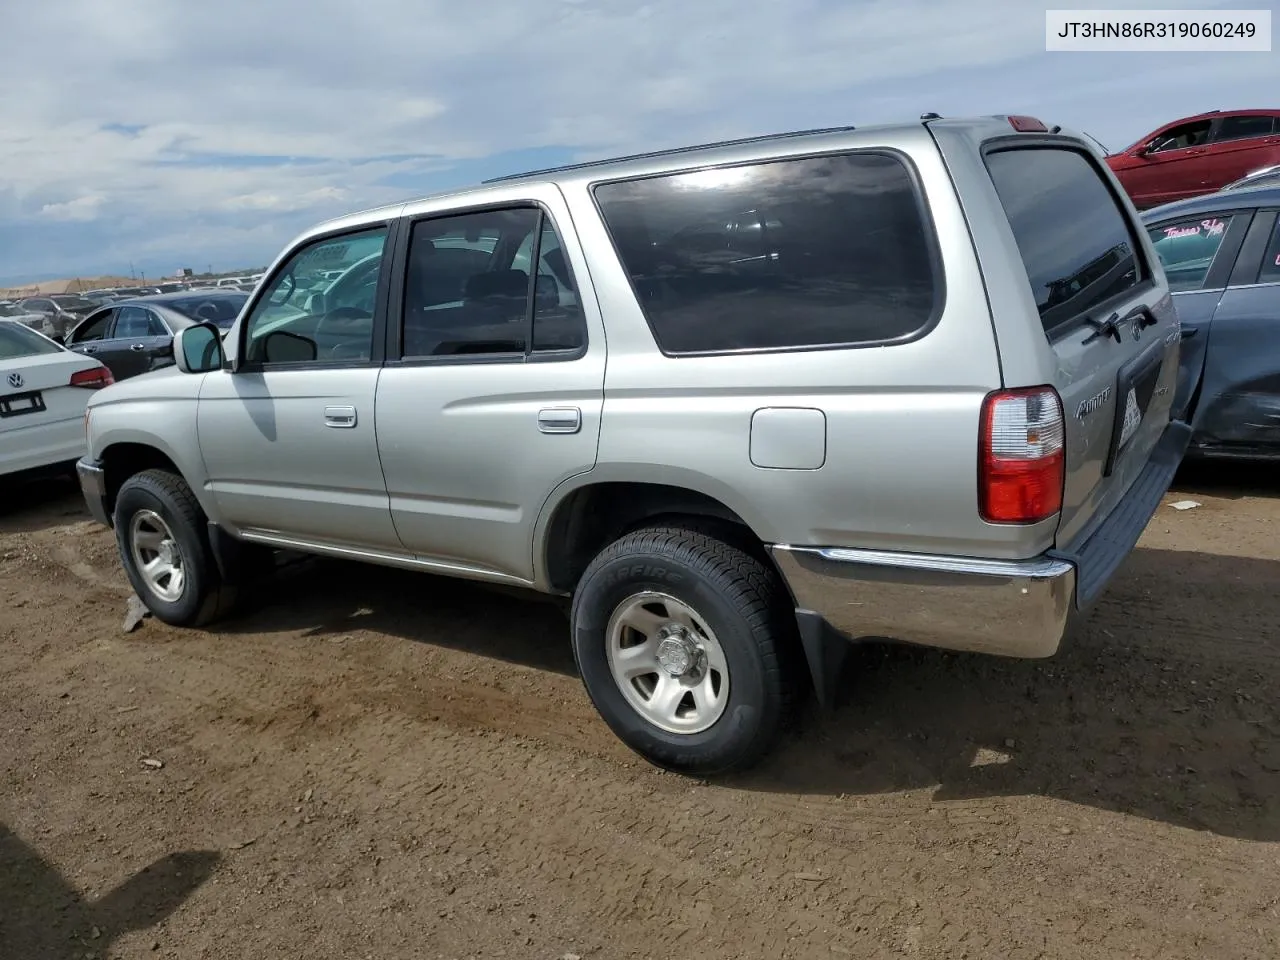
[{"x1": 1107, "y1": 110, "x2": 1280, "y2": 210}]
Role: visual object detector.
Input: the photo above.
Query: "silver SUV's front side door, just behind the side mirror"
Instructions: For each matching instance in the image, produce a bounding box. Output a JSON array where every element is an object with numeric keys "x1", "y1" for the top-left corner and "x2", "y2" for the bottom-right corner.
[{"x1": 197, "y1": 218, "x2": 401, "y2": 553}]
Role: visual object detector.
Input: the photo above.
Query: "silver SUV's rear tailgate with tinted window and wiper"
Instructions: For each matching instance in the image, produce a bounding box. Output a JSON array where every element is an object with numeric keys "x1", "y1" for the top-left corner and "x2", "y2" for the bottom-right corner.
[{"x1": 984, "y1": 136, "x2": 1179, "y2": 547}]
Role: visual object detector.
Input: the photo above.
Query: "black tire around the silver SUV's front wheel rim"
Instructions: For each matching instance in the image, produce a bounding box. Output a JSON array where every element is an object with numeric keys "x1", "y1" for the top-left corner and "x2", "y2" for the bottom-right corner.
[{"x1": 114, "y1": 470, "x2": 237, "y2": 627}]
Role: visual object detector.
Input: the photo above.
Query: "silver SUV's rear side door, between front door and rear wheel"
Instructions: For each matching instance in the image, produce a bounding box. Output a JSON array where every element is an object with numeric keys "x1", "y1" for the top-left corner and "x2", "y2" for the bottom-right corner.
[{"x1": 376, "y1": 192, "x2": 605, "y2": 582}]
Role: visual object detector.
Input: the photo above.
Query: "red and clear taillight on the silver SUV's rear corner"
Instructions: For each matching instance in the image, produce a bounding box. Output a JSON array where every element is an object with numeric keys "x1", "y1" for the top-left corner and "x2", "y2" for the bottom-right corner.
[{"x1": 978, "y1": 387, "x2": 1066, "y2": 524}]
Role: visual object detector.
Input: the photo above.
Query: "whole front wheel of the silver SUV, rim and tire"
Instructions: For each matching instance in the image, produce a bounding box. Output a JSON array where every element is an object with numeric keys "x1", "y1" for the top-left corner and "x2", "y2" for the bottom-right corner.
[{"x1": 114, "y1": 470, "x2": 236, "y2": 627}]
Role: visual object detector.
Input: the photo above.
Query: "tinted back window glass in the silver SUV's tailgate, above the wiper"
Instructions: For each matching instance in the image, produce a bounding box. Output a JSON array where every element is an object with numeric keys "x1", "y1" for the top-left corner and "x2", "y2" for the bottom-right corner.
[{"x1": 987, "y1": 147, "x2": 1142, "y2": 330}]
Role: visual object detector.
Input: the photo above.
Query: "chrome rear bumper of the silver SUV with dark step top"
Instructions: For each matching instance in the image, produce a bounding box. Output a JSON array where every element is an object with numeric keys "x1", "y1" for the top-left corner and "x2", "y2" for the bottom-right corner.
[{"x1": 771, "y1": 422, "x2": 1192, "y2": 658}]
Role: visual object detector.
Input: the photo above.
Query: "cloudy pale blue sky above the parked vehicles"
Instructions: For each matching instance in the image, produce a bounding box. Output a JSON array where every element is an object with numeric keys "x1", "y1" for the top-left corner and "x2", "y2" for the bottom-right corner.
[{"x1": 0, "y1": 0, "x2": 1280, "y2": 283}]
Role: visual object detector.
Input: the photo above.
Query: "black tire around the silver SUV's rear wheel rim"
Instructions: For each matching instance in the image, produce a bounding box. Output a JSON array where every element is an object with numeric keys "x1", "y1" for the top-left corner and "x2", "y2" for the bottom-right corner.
[{"x1": 571, "y1": 526, "x2": 800, "y2": 776}]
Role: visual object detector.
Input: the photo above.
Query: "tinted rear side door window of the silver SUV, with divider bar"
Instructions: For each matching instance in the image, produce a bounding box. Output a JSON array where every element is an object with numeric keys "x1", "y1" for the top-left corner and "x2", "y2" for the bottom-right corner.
[{"x1": 402, "y1": 207, "x2": 586, "y2": 360}]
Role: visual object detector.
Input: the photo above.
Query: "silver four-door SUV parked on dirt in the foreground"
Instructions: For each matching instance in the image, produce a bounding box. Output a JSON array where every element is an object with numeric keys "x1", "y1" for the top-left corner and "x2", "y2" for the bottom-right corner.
[{"x1": 72, "y1": 116, "x2": 1189, "y2": 774}]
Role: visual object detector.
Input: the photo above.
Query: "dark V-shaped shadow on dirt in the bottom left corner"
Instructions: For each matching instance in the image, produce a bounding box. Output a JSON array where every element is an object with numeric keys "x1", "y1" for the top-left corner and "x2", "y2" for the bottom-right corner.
[{"x1": 0, "y1": 823, "x2": 219, "y2": 960}]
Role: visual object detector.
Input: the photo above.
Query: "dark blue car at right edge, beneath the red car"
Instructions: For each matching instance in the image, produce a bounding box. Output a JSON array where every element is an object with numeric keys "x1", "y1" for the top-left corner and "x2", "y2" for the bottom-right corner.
[{"x1": 1142, "y1": 186, "x2": 1280, "y2": 460}]
